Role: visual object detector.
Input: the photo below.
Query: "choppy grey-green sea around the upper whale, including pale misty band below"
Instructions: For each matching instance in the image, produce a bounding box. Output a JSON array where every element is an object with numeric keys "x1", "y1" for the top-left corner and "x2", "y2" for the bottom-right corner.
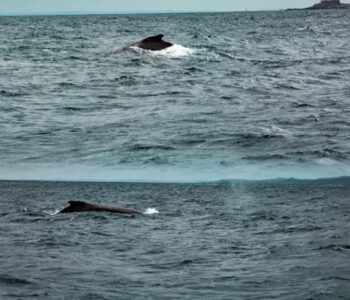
[{"x1": 0, "y1": 10, "x2": 350, "y2": 181}]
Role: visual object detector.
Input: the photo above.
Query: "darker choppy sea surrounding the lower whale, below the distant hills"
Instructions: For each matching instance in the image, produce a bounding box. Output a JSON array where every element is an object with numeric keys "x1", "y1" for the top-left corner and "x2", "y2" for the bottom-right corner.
[{"x1": 0, "y1": 181, "x2": 350, "y2": 300}]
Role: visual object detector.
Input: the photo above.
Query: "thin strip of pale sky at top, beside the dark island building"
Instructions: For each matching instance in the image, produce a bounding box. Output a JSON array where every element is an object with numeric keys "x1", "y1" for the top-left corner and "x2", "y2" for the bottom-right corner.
[{"x1": 0, "y1": 0, "x2": 349, "y2": 14}]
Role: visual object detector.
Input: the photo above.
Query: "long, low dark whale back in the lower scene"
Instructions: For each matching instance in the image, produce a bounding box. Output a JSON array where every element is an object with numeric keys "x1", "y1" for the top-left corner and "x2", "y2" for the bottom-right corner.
[{"x1": 59, "y1": 201, "x2": 142, "y2": 215}]
